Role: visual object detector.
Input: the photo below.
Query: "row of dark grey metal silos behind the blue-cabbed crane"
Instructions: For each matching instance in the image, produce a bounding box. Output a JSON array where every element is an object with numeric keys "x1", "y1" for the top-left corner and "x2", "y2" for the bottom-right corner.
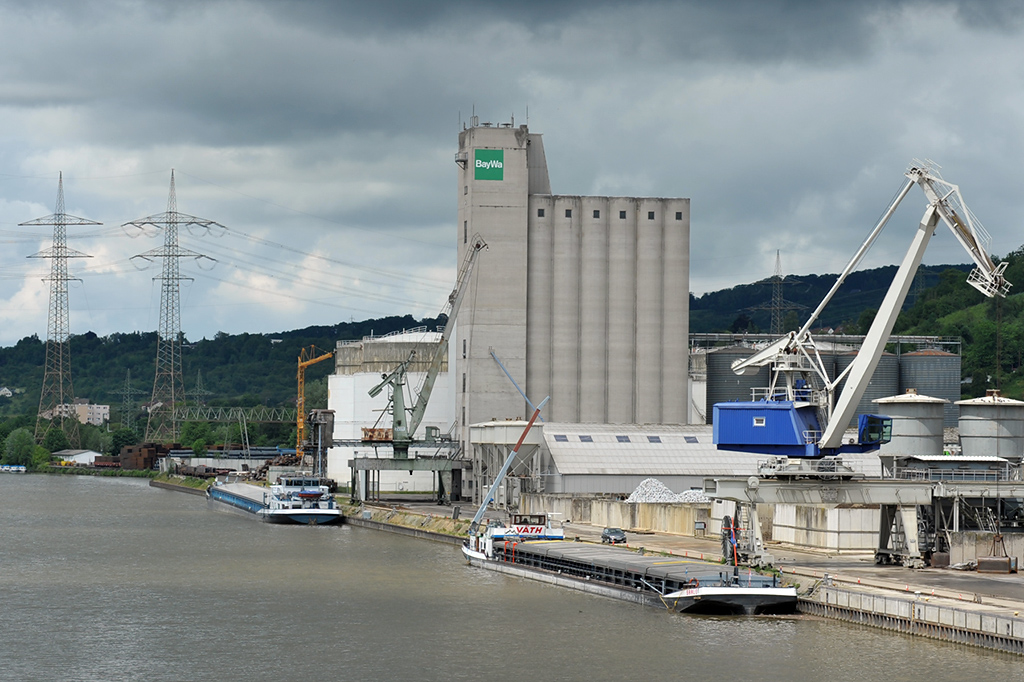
[{"x1": 706, "y1": 346, "x2": 961, "y2": 427}]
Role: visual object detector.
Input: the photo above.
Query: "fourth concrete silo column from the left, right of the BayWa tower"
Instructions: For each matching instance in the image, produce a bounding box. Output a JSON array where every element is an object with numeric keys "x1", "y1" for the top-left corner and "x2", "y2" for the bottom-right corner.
[{"x1": 608, "y1": 198, "x2": 637, "y2": 424}]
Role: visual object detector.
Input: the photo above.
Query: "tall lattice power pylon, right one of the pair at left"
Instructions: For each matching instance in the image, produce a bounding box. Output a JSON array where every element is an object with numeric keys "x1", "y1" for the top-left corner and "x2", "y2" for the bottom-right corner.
[{"x1": 125, "y1": 168, "x2": 224, "y2": 442}]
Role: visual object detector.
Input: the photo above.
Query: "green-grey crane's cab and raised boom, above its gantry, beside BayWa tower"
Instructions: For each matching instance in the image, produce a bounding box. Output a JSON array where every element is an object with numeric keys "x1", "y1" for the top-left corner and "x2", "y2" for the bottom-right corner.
[{"x1": 370, "y1": 235, "x2": 487, "y2": 459}]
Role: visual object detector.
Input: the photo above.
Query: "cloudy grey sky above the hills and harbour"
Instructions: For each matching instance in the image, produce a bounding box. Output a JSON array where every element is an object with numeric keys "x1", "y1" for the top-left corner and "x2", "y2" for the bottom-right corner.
[{"x1": 0, "y1": 0, "x2": 1024, "y2": 345}]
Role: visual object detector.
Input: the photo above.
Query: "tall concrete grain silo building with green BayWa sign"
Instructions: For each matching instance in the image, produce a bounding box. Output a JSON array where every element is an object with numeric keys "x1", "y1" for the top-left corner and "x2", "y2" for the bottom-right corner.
[{"x1": 452, "y1": 118, "x2": 690, "y2": 500}]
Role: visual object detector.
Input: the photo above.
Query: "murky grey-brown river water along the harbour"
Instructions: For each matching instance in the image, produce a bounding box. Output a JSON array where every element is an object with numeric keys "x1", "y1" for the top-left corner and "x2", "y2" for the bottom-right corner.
[{"x1": 0, "y1": 475, "x2": 1024, "y2": 682}]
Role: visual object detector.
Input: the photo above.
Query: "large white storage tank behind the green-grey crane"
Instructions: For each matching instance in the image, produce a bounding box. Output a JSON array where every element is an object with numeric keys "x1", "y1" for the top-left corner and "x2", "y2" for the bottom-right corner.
[{"x1": 328, "y1": 327, "x2": 455, "y2": 485}]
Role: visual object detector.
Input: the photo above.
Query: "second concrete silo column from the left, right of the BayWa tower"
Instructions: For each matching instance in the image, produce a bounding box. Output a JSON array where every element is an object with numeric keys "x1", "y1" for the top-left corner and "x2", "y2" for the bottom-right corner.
[{"x1": 549, "y1": 197, "x2": 582, "y2": 422}]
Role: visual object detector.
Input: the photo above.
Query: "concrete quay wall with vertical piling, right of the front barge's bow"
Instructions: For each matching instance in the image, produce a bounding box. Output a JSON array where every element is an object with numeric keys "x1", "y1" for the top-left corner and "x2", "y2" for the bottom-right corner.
[{"x1": 798, "y1": 585, "x2": 1024, "y2": 654}]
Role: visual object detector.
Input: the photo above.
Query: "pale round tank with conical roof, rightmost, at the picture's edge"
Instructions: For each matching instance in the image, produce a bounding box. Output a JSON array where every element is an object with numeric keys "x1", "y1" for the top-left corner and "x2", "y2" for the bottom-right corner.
[{"x1": 956, "y1": 391, "x2": 1024, "y2": 464}]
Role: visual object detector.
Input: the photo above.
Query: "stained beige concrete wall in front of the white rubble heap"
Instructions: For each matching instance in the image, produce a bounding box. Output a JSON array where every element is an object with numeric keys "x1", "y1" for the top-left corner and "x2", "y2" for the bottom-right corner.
[{"x1": 520, "y1": 493, "x2": 721, "y2": 537}]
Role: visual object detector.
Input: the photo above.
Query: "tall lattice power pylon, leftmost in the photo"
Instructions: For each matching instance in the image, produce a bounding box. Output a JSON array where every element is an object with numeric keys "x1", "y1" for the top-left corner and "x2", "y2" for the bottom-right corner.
[{"x1": 20, "y1": 172, "x2": 102, "y2": 447}]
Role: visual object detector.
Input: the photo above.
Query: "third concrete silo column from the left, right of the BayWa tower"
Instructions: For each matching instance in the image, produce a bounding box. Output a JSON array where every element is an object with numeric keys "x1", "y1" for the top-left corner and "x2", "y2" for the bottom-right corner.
[{"x1": 580, "y1": 197, "x2": 608, "y2": 424}]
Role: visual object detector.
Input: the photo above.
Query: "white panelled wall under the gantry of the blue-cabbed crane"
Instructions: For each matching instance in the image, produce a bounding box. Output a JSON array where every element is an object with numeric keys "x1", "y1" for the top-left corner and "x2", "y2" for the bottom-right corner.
[{"x1": 771, "y1": 505, "x2": 880, "y2": 554}]
